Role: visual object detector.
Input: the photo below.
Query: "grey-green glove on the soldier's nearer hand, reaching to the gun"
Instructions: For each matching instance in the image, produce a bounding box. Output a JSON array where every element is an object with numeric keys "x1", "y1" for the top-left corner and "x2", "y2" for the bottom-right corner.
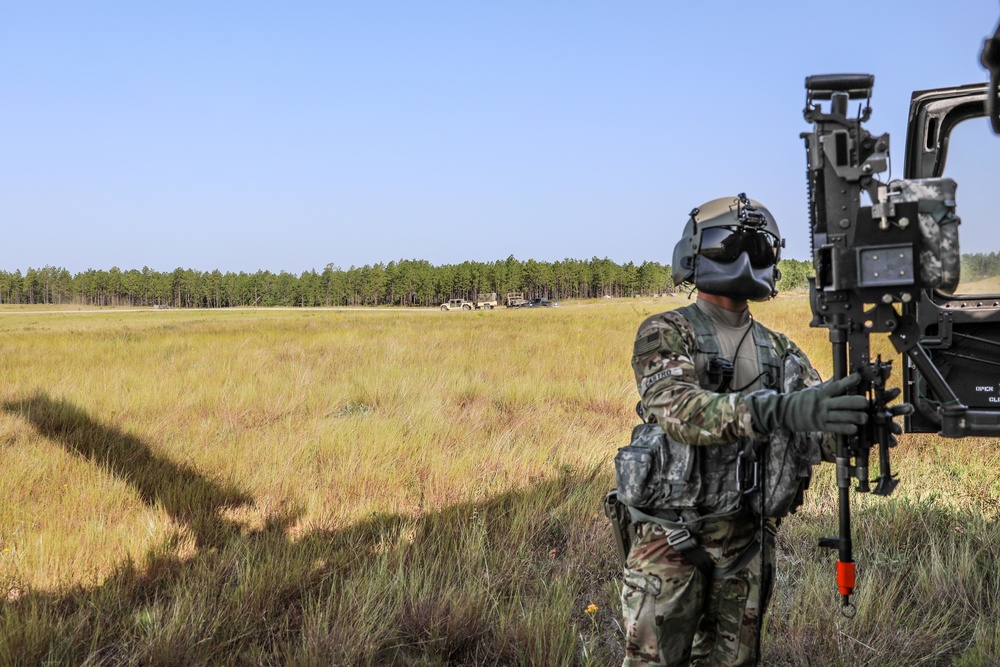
[{"x1": 745, "y1": 373, "x2": 868, "y2": 435}]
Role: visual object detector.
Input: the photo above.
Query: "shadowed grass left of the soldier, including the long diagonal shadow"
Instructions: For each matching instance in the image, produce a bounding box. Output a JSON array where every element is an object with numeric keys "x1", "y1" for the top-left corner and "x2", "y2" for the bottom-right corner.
[{"x1": 0, "y1": 393, "x2": 621, "y2": 665}]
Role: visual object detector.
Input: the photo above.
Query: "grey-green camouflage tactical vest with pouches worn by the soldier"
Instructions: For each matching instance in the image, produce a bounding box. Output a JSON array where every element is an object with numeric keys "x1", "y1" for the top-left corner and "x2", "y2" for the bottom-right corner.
[{"x1": 615, "y1": 304, "x2": 820, "y2": 521}]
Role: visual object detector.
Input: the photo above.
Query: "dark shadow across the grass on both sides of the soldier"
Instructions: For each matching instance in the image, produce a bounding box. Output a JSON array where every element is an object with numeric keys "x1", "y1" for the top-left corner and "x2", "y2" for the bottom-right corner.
[{"x1": 0, "y1": 394, "x2": 1000, "y2": 667}]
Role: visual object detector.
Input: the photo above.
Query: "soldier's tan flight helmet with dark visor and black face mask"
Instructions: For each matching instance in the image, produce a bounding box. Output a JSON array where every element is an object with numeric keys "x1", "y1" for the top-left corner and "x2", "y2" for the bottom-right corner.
[{"x1": 671, "y1": 193, "x2": 785, "y2": 301}]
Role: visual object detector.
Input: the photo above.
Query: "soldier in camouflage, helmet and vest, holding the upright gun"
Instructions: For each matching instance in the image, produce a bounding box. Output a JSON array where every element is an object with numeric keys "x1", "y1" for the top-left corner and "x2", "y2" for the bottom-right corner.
[{"x1": 615, "y1": 194, "x2": 908, "y2": 666}]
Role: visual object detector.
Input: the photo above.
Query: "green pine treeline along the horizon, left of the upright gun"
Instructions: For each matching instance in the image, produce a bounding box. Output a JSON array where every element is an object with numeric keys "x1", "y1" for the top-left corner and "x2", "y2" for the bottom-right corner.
[{"x1": 0, "y1": 256, "x2": 844, "y2": 308}]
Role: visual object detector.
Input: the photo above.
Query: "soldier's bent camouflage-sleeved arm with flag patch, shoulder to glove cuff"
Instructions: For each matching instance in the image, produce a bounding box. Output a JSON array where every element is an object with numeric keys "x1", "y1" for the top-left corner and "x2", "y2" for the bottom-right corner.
[{"x1": 632, "y1": 312, "x2": 766, "y2": 445}]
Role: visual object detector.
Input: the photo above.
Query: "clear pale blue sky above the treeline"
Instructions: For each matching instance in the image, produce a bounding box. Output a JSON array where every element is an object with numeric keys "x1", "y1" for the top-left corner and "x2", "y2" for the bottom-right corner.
[{"x1": 0, "y1": 0, "x2": 1000, "y2": 273}]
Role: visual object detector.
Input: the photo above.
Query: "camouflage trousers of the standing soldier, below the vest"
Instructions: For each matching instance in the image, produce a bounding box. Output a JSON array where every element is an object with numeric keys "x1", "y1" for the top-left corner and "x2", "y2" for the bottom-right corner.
[{"x1": 622, "y1": 517, "x2": 774, "y2": 667}]
